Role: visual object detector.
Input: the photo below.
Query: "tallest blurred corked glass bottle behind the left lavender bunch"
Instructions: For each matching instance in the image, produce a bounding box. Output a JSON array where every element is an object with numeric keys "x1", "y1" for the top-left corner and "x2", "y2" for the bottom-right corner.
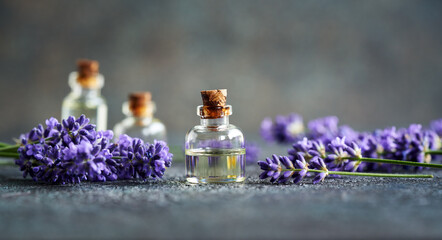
[{"x1": 61, "y1": 60, "x2": 107, "y2": 130}]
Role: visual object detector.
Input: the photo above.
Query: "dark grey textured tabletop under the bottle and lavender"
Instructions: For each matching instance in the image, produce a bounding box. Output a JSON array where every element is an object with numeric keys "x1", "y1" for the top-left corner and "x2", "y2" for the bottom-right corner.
[{"x1": 0, "y1": 158, "x2": 442, "y2": 239}]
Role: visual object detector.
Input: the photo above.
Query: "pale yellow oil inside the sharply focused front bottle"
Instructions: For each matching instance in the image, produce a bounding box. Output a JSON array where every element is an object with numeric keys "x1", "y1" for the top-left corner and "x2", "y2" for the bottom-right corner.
[{"x1": 186, "y1": 148, "x2": 246, "y2": 183}]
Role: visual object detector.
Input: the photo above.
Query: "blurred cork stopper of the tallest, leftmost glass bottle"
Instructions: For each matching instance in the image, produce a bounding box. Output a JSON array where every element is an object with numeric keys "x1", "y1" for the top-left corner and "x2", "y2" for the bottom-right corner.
[{"x1": 77, "y1": 59, "x2": 99, "y2": 88}]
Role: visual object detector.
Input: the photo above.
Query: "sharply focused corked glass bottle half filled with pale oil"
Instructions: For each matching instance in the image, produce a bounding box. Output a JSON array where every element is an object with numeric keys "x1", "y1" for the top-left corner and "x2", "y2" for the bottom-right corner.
[{"x1": 185, "y1": 89, "x2": 245, "y2": 183}]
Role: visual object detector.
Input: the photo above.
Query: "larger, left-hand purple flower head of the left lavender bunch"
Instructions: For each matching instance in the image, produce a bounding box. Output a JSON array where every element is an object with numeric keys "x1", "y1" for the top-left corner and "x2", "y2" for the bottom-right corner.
[{"x1": 16, "y1": 115, "x2": 116, "y2": 184}]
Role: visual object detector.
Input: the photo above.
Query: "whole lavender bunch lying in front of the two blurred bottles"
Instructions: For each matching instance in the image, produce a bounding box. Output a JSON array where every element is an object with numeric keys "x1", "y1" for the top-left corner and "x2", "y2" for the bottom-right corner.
[{"x1": 0, "y1": 115, "x2": 173, "y2": 184}]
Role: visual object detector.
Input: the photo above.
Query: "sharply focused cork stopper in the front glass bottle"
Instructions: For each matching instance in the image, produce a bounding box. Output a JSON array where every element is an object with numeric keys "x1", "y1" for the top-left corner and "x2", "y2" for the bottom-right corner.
[{"x1": 199, "y1": 89, "x2": 230, "y2": 119}]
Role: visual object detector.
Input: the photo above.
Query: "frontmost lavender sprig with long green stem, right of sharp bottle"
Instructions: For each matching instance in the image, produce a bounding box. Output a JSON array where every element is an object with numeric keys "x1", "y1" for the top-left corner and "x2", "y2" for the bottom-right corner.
[{"x1": 258, "y1": 154, "x2": 433, "y2": 184}]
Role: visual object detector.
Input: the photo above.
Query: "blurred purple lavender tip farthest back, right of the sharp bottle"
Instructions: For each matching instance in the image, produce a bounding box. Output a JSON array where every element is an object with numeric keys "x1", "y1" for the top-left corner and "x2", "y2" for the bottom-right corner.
[{"x1": 261, "y1": 113, "x2": 304, "y2": 143}]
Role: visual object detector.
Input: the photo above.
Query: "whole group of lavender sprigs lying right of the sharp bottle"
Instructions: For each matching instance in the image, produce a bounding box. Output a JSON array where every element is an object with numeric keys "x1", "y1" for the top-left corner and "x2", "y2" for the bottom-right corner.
[{"x1": 258, "y1": 114, "x2": 442, "y2": 183}]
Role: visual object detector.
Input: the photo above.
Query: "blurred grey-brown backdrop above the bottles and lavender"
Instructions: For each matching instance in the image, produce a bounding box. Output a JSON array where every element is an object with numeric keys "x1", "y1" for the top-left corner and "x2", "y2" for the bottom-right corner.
[{"x1": 0, "y1": 0, "x2": 442, "y2": 142}]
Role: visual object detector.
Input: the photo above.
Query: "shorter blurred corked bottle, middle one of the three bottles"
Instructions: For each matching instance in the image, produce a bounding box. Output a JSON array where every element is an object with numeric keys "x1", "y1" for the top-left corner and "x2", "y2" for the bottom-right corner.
[{"x1": 114, "y1": 92, "x2": 167, "y2": 143}]
